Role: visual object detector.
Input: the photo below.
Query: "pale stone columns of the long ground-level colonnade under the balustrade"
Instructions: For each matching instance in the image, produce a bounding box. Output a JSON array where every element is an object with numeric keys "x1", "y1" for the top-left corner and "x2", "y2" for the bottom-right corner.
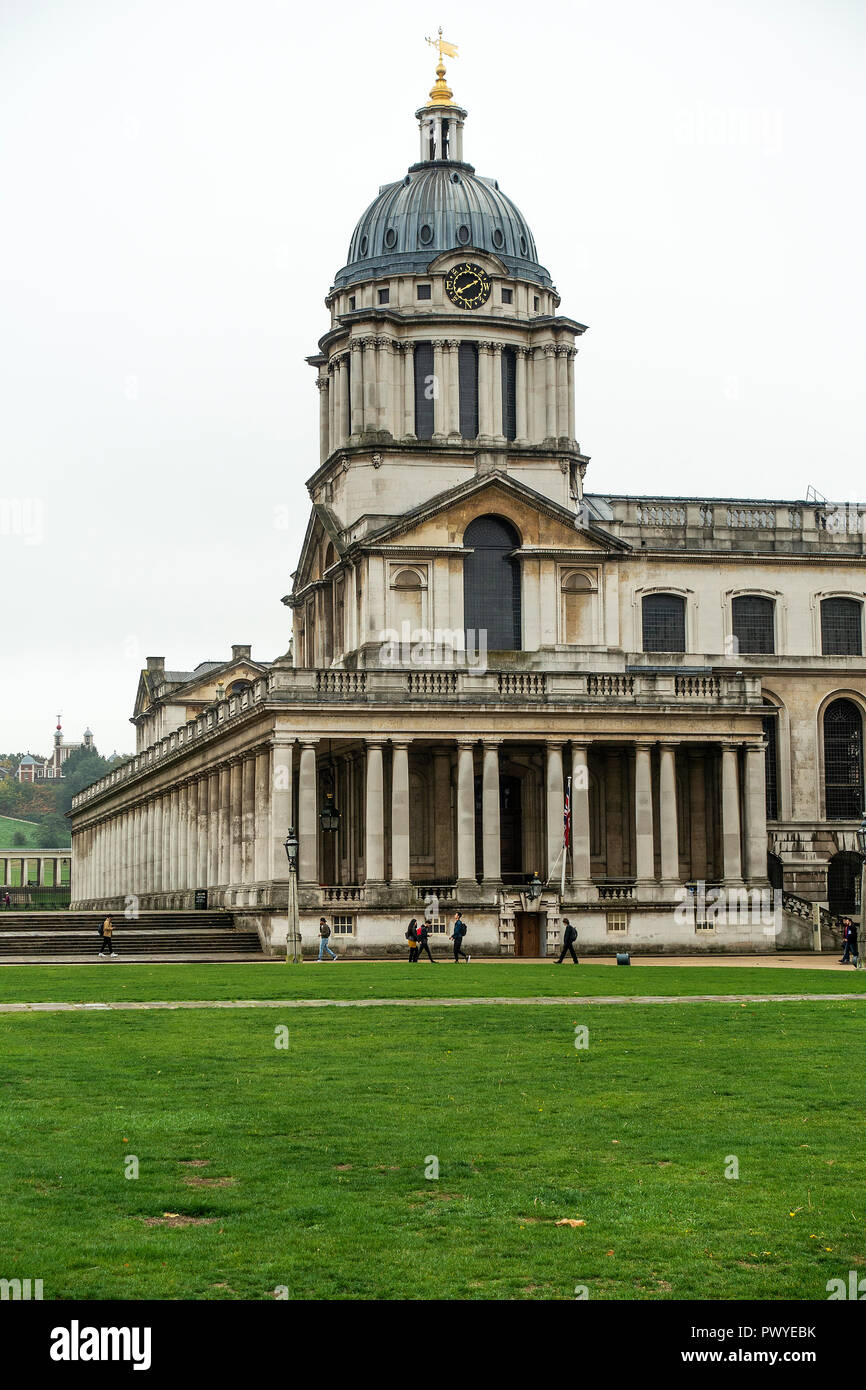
[{"x1": 72, "y1": 734, "x2": 767, "y2": 902}]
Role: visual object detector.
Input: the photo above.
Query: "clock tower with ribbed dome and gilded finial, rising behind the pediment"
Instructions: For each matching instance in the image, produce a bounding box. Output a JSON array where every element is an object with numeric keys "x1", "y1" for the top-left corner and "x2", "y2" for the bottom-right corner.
[{"x1": 294, "y1": 44, "x2": 587, "y2": 664}]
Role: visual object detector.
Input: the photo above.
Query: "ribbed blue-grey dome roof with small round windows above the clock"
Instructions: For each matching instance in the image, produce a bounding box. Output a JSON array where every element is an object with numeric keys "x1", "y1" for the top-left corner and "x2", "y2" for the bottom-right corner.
[{"x1": 334, "y1": 160, "x2": 552, "y2": 289}]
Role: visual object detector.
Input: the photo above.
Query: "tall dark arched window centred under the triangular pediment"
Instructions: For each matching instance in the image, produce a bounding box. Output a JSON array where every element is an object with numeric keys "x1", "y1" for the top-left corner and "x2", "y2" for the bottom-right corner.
[{"x1": 463, "y1": 516, "x2": 521, "y2": 652}]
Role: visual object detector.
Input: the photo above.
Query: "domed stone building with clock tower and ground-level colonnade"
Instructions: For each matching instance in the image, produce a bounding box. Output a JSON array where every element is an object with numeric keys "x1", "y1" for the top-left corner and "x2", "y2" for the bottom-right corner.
[{"x1": 72, "y1": 67, "x2": 866, "y2": 955}]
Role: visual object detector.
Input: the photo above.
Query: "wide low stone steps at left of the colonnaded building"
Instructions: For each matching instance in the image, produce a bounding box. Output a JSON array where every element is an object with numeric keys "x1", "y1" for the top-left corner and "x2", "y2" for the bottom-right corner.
[{"x1": 0, "y1": 912, "x2": 265, "y2": 963}]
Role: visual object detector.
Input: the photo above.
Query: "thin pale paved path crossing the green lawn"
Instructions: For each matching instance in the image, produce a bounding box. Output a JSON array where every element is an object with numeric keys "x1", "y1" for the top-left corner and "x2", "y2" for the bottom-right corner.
[{"x1": 0, "y1": 994, "x2": 866, "y2": 1013}]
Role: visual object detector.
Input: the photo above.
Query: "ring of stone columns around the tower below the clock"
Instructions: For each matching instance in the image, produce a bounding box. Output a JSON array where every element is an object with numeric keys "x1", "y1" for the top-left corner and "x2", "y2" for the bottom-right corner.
[{"x1": 317, "y1": 334, "x2": 577, "y2": 463}]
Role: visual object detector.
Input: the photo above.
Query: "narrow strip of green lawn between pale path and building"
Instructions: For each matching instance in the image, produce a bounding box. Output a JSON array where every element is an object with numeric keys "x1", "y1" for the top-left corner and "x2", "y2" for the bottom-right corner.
[{"x1": 0, "y1": 961, "x2": 866, "y2": 1002}]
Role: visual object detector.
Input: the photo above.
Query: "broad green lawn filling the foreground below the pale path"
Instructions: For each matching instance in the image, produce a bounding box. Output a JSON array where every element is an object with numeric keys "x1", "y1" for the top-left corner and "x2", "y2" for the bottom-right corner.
[{"x1": 0, "y1": 965, "x2": 866, "y2": 1300}]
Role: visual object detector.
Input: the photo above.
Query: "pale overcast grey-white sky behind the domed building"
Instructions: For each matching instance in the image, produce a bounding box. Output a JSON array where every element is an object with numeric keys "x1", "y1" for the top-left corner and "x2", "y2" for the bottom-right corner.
[{"x1": 0, "y1": 0, "x2": 866, "y2": 752}]
